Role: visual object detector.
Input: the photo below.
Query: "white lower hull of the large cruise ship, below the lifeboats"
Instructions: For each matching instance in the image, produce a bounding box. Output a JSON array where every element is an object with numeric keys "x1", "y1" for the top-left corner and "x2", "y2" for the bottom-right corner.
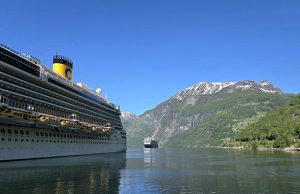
[{"x1": 0, "y1": 124, "x2": 126, "y2": 161}]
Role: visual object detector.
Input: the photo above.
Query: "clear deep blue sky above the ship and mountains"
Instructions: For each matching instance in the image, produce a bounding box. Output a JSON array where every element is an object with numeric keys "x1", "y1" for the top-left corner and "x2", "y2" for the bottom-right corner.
[{"x1": 0, "y1": 0, "x2": 300, "y2": 114}]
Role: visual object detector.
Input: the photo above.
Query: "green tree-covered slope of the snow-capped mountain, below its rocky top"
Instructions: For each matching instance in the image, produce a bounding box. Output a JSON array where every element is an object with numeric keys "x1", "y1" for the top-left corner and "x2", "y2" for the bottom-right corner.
[{"x1": 165, "y1": 91, "x2": 290, "y2": 147}]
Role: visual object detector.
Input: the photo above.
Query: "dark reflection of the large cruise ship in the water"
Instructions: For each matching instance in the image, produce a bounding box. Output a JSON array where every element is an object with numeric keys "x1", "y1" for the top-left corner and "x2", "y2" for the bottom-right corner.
[{"x1": 0, "y1": 153, "x2": 126, "y2": 194}]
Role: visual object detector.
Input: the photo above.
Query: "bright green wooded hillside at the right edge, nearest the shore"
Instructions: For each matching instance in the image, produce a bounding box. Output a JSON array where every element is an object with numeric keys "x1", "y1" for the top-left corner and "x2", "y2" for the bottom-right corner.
[{"x1": 237, "y1": 95, "x2": 300, "y2": 148}]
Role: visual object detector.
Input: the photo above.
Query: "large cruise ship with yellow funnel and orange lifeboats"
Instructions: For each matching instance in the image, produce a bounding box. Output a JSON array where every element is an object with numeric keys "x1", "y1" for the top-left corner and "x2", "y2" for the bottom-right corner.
[{"x1": 0, "y1": 44, "x2": 126, "y2": 161}]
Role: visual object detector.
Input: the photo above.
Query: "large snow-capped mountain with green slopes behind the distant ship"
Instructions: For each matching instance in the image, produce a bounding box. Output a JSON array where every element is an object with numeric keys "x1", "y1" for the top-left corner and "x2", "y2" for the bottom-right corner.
[{"x1": 122, "y1": 80, "x2": 290, "y2": 147}]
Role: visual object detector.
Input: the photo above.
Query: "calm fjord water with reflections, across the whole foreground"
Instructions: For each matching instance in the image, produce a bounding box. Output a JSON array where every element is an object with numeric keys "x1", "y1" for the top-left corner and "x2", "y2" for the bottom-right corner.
[{"x1": 0, "y1": 149, "x2": 300, "y2": 194}]
